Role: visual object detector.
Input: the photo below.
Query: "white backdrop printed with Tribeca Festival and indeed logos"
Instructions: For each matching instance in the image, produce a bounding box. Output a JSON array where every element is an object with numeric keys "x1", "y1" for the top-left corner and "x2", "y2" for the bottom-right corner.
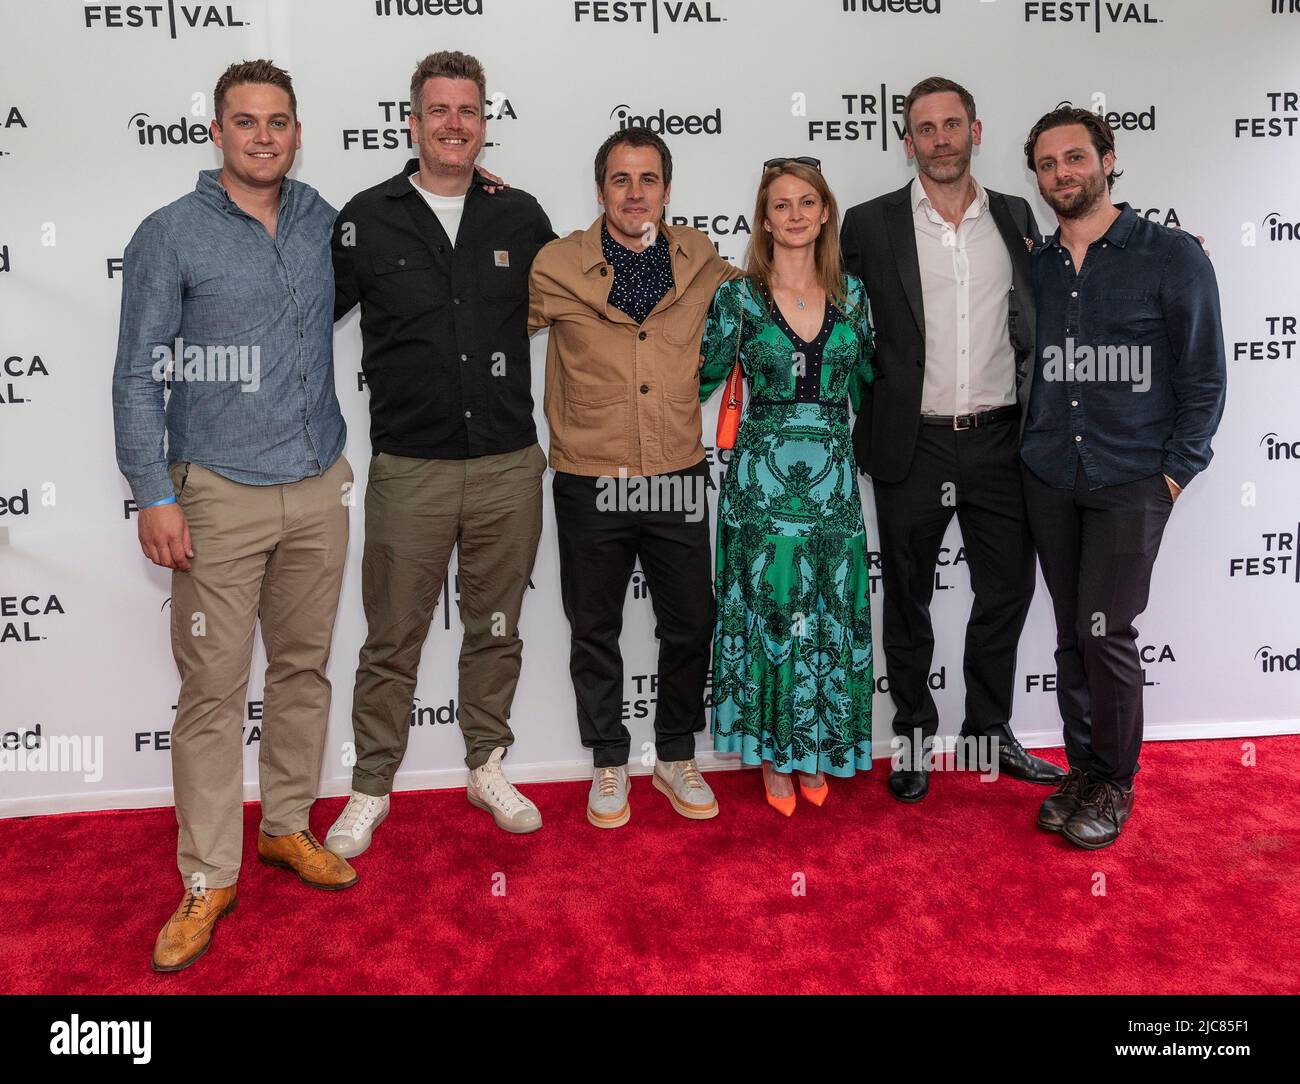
[{"x1": 0, "y1": 0, "x2": 1300, "y2": 815}]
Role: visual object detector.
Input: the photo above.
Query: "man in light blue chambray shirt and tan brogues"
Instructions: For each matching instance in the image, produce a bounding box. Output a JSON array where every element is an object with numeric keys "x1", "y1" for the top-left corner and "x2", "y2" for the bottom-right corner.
[{"x1": 113, "y1": 60, "x2": 356, "y2": 971}]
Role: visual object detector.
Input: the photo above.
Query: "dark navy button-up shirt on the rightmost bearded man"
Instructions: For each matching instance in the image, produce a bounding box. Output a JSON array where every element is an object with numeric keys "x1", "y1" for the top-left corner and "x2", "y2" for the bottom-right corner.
[{"x1": 1021, "y1": 203, "x2": 1227, "y2": 489}]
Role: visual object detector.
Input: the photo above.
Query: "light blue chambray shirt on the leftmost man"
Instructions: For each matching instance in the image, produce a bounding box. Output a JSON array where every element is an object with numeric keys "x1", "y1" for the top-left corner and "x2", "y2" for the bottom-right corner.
[{"x1": 113, "y1": 169, "x2": 347, "y2": 507}]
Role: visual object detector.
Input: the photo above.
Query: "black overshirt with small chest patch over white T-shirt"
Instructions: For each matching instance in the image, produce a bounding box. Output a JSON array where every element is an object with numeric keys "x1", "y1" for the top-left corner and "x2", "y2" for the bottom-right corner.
[{"x1": 333, "y1": 159, "x2": 555, "y2": 459}]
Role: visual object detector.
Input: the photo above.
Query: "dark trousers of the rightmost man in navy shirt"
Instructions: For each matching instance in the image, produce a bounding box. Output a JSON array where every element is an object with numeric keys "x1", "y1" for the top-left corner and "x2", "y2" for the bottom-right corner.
[{"x1": 1023, "y1": 465, "x2": 1174, "y2": 789}]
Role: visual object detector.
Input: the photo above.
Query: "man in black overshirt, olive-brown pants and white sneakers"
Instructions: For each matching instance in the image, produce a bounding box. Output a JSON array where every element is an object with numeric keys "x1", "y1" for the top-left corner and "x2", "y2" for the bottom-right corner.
[{"x1": 325, "y1": 52, "x2": 555, "y2": 855}]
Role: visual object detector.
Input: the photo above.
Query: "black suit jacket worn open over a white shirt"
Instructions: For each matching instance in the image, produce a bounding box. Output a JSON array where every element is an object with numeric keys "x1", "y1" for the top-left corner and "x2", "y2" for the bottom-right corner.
[{"x1": 840, "y1": 182, "x2": 1043, "y2": 482}]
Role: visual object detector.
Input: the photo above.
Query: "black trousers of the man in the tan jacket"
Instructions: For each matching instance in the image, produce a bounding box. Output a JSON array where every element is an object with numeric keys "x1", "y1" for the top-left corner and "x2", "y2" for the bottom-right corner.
[{"x1": 551, "y1": 461, "x2": 714, "y2": 768}]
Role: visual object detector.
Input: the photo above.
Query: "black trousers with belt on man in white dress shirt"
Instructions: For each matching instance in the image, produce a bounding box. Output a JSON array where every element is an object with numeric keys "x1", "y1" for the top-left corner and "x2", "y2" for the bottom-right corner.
[{"x1": 874, "y1": 417, "x2": 1034, "y2": 740}]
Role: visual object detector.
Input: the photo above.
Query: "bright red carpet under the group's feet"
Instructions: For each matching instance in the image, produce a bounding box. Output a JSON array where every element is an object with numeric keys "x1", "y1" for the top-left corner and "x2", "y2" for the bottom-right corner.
[{"x1": 0, "y1": 737, "x2": 1300, "y2": 993}]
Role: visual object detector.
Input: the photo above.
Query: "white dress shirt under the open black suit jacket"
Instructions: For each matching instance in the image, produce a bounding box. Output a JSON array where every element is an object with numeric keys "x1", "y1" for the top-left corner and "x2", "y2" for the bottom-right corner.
[{"x1": 911, "y1": 177, "x2": 1015, "y2": 415}]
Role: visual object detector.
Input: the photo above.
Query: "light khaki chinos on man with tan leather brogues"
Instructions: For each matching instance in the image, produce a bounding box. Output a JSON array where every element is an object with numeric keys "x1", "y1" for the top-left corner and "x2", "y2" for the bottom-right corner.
[{"x1": 170, "y1": 456, "x2": 352, "y2": 888}]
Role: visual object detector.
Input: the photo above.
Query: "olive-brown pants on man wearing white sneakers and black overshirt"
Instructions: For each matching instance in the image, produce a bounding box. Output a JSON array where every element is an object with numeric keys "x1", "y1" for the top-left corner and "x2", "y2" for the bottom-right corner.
[{"x1": 352, "y1": 443, "x2": 546, "y2": 797}]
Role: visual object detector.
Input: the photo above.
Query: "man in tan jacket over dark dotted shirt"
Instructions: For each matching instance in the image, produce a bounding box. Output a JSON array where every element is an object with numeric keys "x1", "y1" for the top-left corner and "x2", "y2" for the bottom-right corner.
[{"x1": 529, "y1": 127, "x2": 740, "y2": 828}]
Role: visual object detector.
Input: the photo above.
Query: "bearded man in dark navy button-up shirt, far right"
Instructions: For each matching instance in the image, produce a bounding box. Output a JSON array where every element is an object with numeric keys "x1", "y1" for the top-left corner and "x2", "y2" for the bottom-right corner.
[{"x1": 1021, "y1": 105, "x2": 1227, "y2": 850}]
